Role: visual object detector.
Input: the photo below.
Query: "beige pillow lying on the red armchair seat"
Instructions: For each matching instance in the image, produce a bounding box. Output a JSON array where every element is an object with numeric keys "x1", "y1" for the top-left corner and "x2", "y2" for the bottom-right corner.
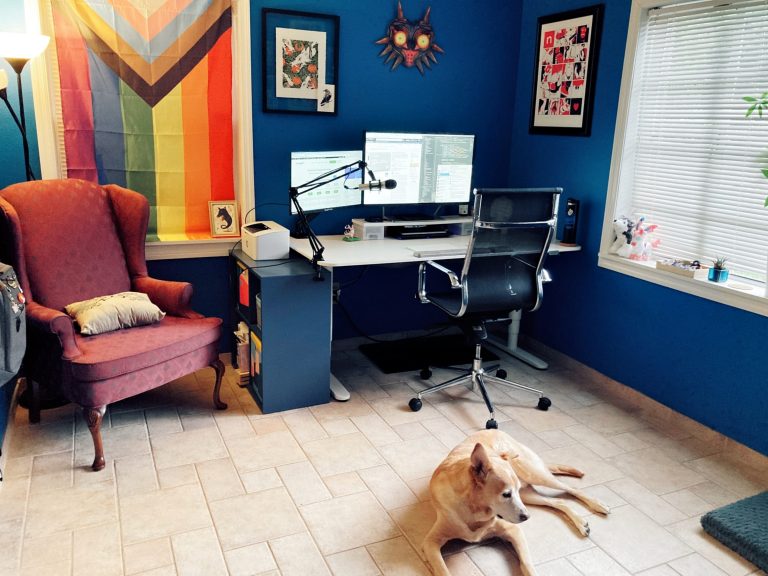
[{"x1": 64, "y1": 292, "x2": 165, "y2": 336}]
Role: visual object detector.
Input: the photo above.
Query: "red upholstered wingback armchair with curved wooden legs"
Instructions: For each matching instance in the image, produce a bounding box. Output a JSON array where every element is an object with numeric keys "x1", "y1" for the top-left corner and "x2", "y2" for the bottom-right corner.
[{"x1": 0, "y1": 180, "x2": 227, "y2": 470}]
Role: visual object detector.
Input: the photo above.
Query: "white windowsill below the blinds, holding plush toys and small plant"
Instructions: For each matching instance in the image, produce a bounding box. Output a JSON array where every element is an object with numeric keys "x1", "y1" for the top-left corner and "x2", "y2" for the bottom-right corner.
[{"x1": 597, "y1": 254, "x2": 768, "y2": 316}]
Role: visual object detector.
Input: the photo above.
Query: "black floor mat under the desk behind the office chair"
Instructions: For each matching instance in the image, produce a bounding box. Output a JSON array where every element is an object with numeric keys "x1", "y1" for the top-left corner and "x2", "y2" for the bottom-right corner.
[{"x1": 360, "y1": 334, "x2": 499, "y2": 374}]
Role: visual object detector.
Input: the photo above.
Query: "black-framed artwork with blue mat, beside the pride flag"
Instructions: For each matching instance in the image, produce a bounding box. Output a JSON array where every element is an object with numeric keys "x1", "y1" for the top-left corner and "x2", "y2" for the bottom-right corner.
[{"x1": 261, "y1": 8, "x2": 339, "y2": 114}]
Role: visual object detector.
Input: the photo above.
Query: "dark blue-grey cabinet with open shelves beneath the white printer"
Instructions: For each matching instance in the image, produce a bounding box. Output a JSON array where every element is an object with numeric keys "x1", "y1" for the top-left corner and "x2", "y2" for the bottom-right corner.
[{"x1": 230, "y1": 250, "x2": 331, "y2": 414}]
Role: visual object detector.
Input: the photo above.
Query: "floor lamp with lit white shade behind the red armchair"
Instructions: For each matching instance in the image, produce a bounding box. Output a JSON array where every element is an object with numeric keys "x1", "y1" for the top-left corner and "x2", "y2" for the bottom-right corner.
[{"x1": 0, "y1": 32, "x2": 49, "y2": 180}]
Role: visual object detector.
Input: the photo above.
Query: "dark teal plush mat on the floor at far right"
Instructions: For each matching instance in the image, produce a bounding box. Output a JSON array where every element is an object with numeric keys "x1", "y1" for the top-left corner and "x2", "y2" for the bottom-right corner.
[{"x1": 701, "y1": 492, "x2": 768, "y2": 572}]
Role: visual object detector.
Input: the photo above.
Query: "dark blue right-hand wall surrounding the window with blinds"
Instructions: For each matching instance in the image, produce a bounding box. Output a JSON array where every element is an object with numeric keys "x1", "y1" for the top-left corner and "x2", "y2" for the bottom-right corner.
[{"x1": 509, "y1": 0, "x2": 768, "y2": 454}]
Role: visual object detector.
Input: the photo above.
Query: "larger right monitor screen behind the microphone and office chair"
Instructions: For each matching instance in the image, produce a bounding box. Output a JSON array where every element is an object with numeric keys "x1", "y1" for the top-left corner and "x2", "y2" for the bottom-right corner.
[{"x1": 363, "y1": 132, "x2": 475, "y2": 204}]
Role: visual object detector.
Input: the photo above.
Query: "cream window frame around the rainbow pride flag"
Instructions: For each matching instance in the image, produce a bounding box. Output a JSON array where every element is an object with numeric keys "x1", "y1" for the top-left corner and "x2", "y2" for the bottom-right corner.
[{"x1": 24, "y1": 0, "x2": 255, "y2": 260}]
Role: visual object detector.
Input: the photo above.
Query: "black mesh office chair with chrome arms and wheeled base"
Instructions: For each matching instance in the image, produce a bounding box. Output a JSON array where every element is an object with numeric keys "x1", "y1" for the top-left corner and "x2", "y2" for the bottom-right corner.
[{"x1": 409, "y1": 188, "x2": 562, "y2": 428}]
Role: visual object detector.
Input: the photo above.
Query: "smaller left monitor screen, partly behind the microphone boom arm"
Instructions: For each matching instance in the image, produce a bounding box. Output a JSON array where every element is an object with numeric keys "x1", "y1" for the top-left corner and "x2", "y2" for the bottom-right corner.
[{"x1": 290, "y1": 150, "x2": 363, "y2": 214}]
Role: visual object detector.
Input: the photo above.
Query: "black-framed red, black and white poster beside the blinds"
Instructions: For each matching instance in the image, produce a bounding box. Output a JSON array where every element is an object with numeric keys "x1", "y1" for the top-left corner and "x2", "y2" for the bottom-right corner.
[{"x1": 528, "y1": 4, "x2": 603, "y2": 136}]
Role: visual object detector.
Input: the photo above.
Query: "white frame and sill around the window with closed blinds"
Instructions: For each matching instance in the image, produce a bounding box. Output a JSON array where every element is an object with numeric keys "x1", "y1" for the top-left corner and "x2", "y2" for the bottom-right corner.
[{"x1": 598, "y1": 0, "x2": 768, "y2": 316}]
